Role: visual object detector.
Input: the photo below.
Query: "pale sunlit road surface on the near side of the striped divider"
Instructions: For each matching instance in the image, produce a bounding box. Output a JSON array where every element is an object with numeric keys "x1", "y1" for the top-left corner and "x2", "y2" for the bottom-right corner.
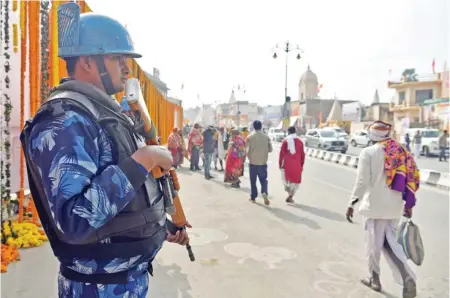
[{"x1": 2, "y1": 150, "x2": 449, "y2": 298}]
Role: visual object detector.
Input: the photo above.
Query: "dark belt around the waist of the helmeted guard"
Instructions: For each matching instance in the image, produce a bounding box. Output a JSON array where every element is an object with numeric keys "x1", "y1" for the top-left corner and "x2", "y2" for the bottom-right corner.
[{"x1": 60, "y1": 262, "x2": 153, "y2": 284}]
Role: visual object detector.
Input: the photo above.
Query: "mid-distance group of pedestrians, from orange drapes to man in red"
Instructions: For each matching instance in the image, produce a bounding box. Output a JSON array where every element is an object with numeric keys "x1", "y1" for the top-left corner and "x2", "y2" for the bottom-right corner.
[{"x1": 168, "y1": 121, "x2": 305, "y2": 205}]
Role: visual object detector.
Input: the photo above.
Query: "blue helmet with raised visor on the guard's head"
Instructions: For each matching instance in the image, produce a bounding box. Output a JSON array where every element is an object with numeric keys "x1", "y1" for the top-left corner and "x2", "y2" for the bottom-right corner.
[{"x1": 58, "y1": 2, "x2": 142, "y2": 58}]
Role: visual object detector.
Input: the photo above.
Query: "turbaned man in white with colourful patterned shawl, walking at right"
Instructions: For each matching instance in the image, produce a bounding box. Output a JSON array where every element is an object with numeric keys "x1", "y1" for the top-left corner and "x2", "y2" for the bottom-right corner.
[{"x1": 346, "y1": 121, "x2": 420, "y2": 298}]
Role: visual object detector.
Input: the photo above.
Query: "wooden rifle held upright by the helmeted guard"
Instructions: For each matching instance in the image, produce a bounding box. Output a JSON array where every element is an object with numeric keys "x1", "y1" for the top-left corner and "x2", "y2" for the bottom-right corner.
[{"x1": 125, "y1": 78, "x2": 195, "y2": 262}]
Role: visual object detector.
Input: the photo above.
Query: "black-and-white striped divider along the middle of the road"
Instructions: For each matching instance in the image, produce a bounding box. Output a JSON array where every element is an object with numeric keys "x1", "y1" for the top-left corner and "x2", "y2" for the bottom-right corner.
[{"x1": 305, "y1": 148, "x2": 450, "y2": 190}]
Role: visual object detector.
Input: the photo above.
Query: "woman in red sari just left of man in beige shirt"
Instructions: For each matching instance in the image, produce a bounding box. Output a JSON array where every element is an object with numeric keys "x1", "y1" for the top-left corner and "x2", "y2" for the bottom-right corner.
[{"x1": 224, "y1": 129, "x2": 245, "y2": 188}]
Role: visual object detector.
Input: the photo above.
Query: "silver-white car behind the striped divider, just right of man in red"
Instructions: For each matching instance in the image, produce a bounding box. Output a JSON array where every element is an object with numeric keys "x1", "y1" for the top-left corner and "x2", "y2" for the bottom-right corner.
[{"x1": 305, "y1": 129, "x2": 348, "y2": 153}]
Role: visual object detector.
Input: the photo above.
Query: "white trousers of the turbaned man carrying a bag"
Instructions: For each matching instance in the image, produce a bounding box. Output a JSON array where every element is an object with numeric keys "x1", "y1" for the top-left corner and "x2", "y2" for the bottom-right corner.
[{"x1": 365, "y1": 219, "x2": 416, "y2": 285}]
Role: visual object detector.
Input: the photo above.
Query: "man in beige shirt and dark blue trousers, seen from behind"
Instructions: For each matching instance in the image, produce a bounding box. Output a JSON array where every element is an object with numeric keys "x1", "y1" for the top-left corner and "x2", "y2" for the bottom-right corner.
[{"x1": 246, "y1": 120, "x2": 272, "y2": 205}]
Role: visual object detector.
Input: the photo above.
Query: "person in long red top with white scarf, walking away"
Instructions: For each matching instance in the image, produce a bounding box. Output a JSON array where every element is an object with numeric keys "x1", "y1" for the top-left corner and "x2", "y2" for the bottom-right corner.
[{"x1": 278, "y1": 126, "x2": 305, "y2": 203}]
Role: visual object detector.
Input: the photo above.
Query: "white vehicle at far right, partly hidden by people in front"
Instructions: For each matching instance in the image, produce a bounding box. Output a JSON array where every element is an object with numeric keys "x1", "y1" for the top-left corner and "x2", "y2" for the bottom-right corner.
[{"x1": 400, "y1": 128, "x2": 449, "y2": 156}]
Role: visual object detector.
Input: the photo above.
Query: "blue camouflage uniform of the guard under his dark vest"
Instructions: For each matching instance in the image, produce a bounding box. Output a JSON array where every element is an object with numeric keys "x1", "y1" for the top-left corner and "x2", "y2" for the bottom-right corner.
[{"x1": 29, "y1": 106, "x2": 158, "y2": 298}]
